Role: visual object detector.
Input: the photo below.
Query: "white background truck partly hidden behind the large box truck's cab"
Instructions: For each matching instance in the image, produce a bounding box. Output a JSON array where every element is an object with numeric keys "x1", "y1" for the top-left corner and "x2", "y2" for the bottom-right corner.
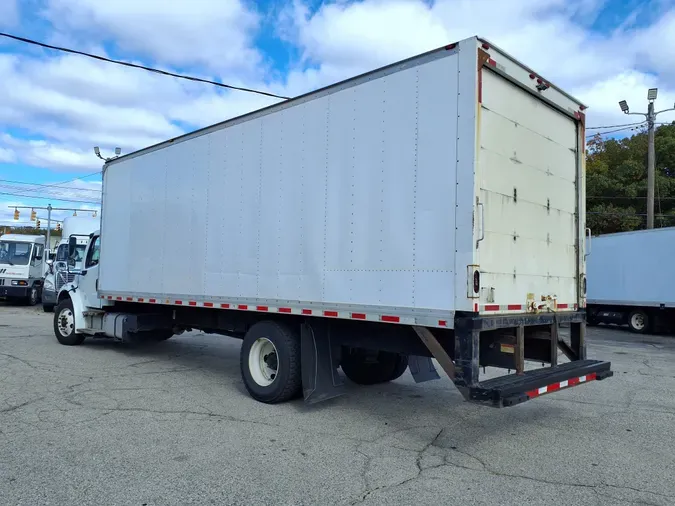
[{"x1": 42, "y1": 216, "x2": 101, "y2": 313}]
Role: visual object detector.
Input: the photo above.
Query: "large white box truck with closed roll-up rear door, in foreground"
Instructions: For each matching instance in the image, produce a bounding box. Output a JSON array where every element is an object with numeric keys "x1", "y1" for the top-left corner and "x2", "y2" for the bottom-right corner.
[{"x1": 54, "y1": 37, "x2": 612, "y2": 407}]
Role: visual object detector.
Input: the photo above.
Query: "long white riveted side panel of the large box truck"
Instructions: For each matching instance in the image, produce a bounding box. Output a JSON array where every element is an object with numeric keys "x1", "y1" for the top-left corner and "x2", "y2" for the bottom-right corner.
[{"x1": 100, "y1": 52, "x2": 458, "y2": 311}]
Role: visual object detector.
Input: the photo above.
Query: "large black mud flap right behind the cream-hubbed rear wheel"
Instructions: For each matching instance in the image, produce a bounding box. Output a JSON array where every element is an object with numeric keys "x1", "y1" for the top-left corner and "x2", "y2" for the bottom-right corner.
[{"x1": 300, "y1": 321, "x2": 345, "y2": 404}]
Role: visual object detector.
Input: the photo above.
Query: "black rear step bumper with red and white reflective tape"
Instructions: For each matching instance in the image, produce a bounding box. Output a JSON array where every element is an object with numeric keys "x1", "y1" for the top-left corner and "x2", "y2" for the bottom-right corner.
[{"x1": 468, "y1": 360, "x2": 614, "y2": 407}]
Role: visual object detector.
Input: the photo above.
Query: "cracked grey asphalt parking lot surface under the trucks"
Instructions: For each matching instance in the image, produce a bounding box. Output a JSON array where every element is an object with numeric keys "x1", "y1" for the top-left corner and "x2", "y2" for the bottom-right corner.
[{"x1": 0, "y1": 303, "x2": 675, "y2": 506}]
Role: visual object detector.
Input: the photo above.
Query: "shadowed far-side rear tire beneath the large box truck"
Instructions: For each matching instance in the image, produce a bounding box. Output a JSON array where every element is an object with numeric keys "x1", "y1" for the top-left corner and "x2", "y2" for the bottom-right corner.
[{"x1": 340, "y1": 349, "x2": 408, "y2": 385}]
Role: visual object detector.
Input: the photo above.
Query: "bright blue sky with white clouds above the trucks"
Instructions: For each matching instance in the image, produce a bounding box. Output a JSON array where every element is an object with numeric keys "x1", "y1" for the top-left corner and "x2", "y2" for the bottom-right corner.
[{"x1": 0, "y1": 0, "x2": 675, "y2": 224}]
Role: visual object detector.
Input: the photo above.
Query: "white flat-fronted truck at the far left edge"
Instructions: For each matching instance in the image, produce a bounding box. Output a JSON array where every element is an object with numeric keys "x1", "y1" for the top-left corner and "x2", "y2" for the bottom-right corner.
[{"x1": 0, "y1": 234, "x2": 46, "y2": 306}]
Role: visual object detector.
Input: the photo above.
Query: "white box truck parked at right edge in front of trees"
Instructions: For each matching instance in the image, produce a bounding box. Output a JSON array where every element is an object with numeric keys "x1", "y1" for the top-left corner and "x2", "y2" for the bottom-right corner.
[{"x1": 586, "y1": 227, "x2": 675, "y2": 334}]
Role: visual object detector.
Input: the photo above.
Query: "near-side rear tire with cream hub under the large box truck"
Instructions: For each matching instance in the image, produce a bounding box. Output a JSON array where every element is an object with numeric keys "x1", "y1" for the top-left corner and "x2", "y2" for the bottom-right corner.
[{"x1": 239, "y1": 321, "x2": 302, "y2": 404}]
